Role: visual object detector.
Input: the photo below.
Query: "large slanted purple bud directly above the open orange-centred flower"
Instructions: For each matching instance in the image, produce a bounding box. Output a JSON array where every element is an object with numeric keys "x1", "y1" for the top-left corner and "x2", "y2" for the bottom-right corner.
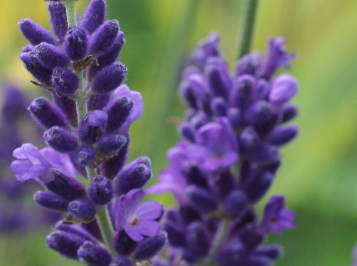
[{"x1": 113, "y1": 156, "x2": 152, "y2": 195}]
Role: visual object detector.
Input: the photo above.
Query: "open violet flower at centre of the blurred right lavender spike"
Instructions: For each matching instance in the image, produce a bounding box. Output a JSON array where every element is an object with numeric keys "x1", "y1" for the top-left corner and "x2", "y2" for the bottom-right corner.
[{"x1": 190, "y1": 118, "x2": 238, "y2": 172}]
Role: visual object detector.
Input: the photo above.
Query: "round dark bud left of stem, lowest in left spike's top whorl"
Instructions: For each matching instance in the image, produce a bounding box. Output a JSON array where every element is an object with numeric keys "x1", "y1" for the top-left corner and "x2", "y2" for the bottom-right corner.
[{"x1": 52, "y1": 67, "x2": 79, "y2": 95}]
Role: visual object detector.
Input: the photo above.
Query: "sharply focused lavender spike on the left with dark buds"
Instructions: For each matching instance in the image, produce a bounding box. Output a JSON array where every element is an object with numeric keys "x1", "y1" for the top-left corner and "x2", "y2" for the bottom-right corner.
[{"x1": 11, "y1": 0, "x2": 167, "y2": 266}]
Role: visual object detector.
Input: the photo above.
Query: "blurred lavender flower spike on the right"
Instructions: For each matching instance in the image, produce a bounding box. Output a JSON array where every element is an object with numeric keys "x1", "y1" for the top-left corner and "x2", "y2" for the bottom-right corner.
[{"x1": 148, "y1": 34, "x2": 298, "y2": 266}]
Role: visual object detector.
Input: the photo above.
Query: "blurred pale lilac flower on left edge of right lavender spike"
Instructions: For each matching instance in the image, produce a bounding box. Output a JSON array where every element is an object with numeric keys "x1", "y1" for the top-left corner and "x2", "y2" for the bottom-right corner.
[{"x1": 147, "y1": 141, "x2": 188, "y2": 205}]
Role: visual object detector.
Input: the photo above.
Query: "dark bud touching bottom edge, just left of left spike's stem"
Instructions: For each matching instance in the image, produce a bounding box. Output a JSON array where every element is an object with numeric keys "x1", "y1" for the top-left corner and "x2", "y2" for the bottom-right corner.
[{"x1": 77, "y1": 241, "x2": 112, "y2": 266}]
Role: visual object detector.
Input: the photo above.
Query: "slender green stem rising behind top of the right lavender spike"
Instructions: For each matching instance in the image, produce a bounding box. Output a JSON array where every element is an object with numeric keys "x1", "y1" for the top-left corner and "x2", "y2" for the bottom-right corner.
[{"x1": 238, "y1": 0, "x2": 259, "y2": 58}]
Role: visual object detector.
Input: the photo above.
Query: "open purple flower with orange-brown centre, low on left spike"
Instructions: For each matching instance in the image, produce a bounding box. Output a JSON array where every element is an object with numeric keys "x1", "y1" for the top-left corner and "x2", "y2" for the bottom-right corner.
[{"x1": 115, "y1": 189, "x2": 163, "y2": 242}]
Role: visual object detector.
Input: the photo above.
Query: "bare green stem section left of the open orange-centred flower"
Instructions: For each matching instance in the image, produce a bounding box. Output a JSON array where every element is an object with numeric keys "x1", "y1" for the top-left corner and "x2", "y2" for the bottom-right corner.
[{"x1": 97, "y1": 206, "x2": 116, "y2": 256}]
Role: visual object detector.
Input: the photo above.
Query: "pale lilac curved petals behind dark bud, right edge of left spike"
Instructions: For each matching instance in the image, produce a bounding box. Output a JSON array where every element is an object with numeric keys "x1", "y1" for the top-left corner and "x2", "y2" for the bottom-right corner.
[{"x1": 113, "y1": 84, "x2": 144, "y2": 135}]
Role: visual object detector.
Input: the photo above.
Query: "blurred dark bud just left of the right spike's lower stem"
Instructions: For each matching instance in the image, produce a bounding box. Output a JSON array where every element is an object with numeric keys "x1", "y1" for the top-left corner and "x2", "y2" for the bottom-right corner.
[{"x1": 186, "y1": 222, "x2": 212, "y2": 257}]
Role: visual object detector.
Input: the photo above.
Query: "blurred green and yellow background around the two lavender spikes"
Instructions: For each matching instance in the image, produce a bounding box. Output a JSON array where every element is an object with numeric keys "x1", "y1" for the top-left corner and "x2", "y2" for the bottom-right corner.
[{"x1": 0, "y1": 0, "x2": 357, "y2": 266}]
